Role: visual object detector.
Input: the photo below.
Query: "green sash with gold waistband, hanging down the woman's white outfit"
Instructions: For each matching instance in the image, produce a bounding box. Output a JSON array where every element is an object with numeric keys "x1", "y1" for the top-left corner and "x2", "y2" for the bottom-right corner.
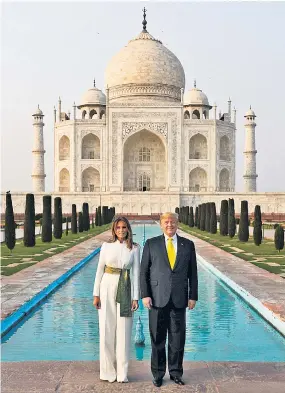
[{"x1": 104, "y1": 266, "x2": 132, "y2": 317}]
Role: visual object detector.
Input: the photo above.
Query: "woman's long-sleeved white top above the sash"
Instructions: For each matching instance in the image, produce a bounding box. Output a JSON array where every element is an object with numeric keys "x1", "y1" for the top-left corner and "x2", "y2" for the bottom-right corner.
[{"x1": 93, "y1": 240, "x2": 140, "y2": 300}]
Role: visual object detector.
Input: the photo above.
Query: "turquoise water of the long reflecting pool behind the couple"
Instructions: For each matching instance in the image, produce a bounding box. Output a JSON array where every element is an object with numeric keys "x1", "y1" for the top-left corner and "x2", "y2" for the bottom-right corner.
[{"x1": 2, "y1": 225, "x2": 285, "y2": 362}]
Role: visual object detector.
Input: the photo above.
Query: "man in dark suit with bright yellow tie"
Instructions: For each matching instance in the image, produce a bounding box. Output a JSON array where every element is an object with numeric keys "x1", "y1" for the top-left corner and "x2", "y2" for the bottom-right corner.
[{"x1": 140, "y1": 213, "x2": 198, "y2": 387}]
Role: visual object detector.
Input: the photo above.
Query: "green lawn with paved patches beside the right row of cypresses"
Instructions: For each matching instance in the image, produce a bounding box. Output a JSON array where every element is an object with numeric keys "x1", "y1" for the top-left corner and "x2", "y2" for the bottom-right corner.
[{"x1": 179, "y1": 223, "x2": 285, "y2": 274}]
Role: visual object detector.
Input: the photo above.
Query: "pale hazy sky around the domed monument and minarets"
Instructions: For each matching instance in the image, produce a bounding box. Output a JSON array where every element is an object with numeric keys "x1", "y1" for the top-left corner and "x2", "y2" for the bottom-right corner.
[{"x1": 1, "y1": 1, "x2": 285, "y2": 192}]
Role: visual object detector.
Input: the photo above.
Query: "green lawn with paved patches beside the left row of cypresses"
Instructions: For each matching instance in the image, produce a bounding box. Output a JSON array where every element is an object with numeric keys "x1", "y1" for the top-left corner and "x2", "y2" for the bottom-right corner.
[{"x1": 1, "y1": 224, "x2": 110, "y2": 276}]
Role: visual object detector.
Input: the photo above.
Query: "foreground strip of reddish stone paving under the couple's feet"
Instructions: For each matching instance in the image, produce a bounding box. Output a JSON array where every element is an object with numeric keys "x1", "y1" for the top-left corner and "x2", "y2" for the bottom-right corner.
[{"x1": 2, "y1": 361, "x2": 285, "y2": 393}]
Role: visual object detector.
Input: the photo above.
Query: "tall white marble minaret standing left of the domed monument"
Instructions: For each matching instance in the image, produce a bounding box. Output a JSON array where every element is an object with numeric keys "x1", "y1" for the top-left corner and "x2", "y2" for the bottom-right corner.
[{"x1": 32, "y1": 106, "x2": 46, "y2": 192}]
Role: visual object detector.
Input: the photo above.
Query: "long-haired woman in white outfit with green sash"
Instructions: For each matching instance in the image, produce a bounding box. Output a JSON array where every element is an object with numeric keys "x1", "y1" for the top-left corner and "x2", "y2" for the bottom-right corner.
[{"x1": 93, "y1": 217, "x2": 140, "y2": 382}]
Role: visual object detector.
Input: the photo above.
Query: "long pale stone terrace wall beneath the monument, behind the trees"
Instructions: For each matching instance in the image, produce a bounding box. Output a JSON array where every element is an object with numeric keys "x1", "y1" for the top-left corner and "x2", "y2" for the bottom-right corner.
[{"x1": 1, "y1": 191, "x2": 285, "y2": 217}]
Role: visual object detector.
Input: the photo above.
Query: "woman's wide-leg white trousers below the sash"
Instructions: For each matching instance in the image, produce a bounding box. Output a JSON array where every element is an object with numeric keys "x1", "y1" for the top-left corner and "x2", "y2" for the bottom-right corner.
[{"x1": 99, "y1": 273, "x2": 133, "y2": 382}]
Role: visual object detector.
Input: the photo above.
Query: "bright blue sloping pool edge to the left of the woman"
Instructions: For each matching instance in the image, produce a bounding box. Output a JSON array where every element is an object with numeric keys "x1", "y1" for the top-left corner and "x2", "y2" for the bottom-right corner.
[{"x1": 1, "y1": 247, "x2": 101, "y2": 338}]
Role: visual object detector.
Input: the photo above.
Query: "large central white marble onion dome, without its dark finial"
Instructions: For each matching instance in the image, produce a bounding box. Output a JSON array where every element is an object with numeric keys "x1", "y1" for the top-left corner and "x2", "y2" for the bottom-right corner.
[{"x1": 105, "y1": 31, "x2": 185, "y2": 100}]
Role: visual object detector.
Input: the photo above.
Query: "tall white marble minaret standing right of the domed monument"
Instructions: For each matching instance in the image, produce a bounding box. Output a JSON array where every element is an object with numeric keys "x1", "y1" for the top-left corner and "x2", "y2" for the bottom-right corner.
[{"x1": 243, "y1": 107, "x2": 257, "y2": 192}]
